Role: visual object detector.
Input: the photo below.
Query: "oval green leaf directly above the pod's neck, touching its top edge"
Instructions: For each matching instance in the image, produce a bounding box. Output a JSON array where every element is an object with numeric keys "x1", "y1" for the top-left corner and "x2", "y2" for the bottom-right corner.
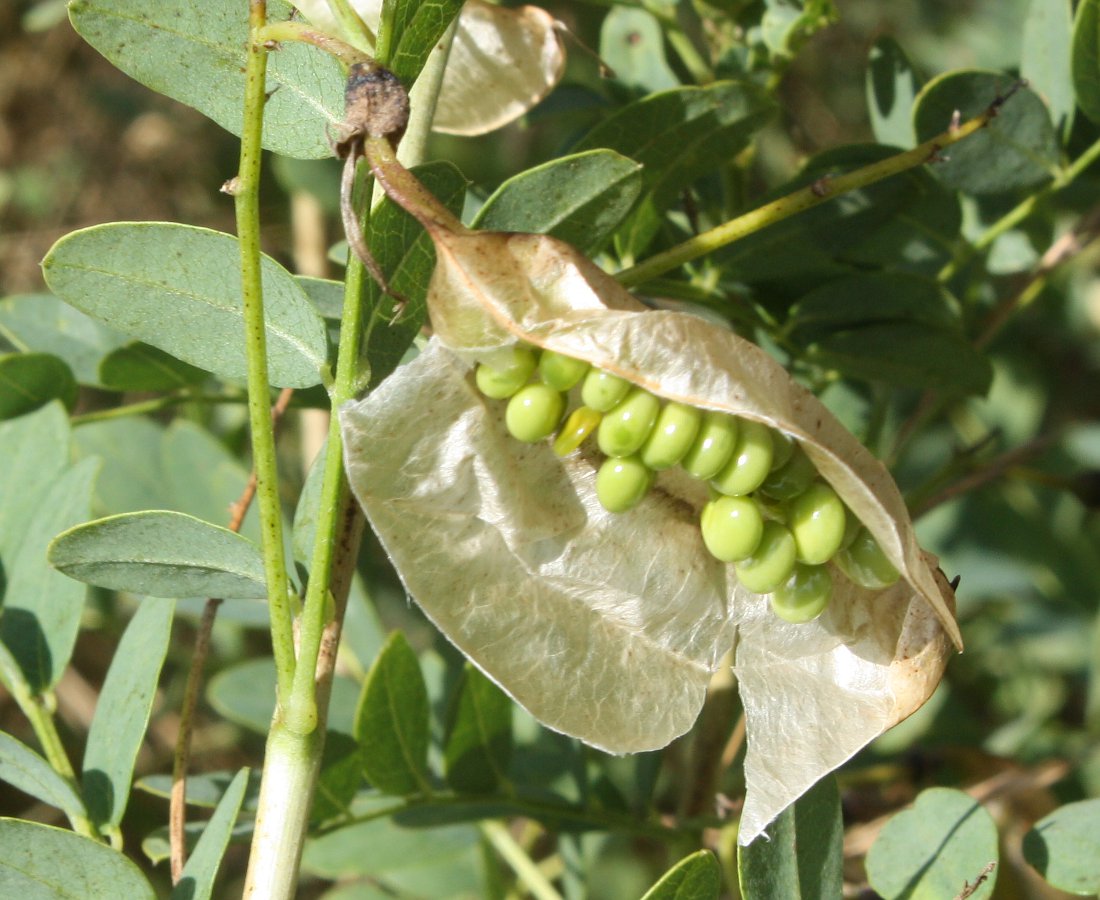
[{"x1": 473, "y1": 150, "x2": 642, "y2": 255}]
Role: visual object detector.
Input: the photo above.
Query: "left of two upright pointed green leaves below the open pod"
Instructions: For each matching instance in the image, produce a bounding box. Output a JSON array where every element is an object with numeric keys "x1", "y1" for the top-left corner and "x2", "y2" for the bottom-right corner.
[{"x1": 354, "y1": 632, "x2": 429, "y2": 795}]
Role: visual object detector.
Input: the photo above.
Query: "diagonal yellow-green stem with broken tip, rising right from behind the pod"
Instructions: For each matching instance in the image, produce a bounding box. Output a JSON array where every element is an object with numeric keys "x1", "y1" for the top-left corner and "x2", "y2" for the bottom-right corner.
[{"x1": 615, "y1": 99, "x2": 1003, "y2": 287}]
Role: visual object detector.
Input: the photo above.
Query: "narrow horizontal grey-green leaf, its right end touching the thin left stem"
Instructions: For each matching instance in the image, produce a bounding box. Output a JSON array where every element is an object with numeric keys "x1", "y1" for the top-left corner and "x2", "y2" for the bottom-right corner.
[{"x1": 50, "y1": 511, "x2": 267, "y2": 600}]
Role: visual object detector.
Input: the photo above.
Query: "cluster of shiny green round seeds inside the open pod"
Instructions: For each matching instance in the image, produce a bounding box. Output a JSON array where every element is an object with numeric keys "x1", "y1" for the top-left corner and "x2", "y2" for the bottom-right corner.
[{"x1": 474, "y1": 344, "x2": 899, "y2": 623}]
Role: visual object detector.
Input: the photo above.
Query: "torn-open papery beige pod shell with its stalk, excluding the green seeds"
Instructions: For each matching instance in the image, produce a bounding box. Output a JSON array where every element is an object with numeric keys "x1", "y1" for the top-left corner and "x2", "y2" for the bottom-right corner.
[{"x1": 340, "y1": 147, "x2": 960, "y2": 844}]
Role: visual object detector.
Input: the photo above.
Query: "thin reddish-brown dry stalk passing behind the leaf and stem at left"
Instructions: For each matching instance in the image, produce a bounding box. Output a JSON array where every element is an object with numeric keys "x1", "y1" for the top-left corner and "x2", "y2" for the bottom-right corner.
[{"x1": 168, "y1": 387, "x2": 294, "y2": 885}]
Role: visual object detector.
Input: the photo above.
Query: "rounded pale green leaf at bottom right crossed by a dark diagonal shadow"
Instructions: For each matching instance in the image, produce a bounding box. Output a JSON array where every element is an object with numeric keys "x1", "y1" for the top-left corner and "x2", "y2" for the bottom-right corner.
[{"x1": 867, "y1": 788, "x2": 999, "y2": 900}]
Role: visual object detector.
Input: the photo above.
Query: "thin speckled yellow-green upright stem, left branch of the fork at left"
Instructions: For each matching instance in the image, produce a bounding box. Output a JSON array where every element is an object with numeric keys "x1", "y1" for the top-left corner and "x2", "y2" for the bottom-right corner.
[{"x1": 234, "y1": 0, "x2": 295, "y2": 703}]
